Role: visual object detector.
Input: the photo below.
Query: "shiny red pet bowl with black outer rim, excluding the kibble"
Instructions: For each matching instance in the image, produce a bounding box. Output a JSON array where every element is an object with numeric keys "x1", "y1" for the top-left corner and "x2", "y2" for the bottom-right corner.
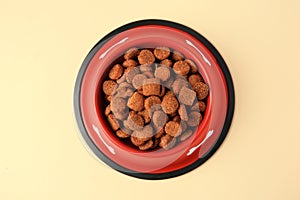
[{"x1": 74, "y1": 20, "x2": 234, "y2": 179}]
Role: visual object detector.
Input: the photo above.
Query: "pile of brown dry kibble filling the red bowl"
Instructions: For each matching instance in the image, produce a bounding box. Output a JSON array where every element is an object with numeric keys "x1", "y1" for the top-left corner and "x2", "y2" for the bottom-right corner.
[{"x1": 102, "y1": 47, "x2": 209, "y2": 150}]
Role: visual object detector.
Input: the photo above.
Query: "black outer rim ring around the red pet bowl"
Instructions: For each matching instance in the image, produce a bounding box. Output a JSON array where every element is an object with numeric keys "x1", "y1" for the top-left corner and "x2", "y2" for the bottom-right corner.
[{"x1": 73, "y1": 19, "x2": 235, "y2": 180}]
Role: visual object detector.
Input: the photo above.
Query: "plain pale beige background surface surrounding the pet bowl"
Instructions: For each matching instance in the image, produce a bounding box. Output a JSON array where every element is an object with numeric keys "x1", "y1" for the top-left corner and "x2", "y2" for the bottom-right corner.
[{"x1": 0, "y1": 0, "x2": 300, "y2": 200}]
